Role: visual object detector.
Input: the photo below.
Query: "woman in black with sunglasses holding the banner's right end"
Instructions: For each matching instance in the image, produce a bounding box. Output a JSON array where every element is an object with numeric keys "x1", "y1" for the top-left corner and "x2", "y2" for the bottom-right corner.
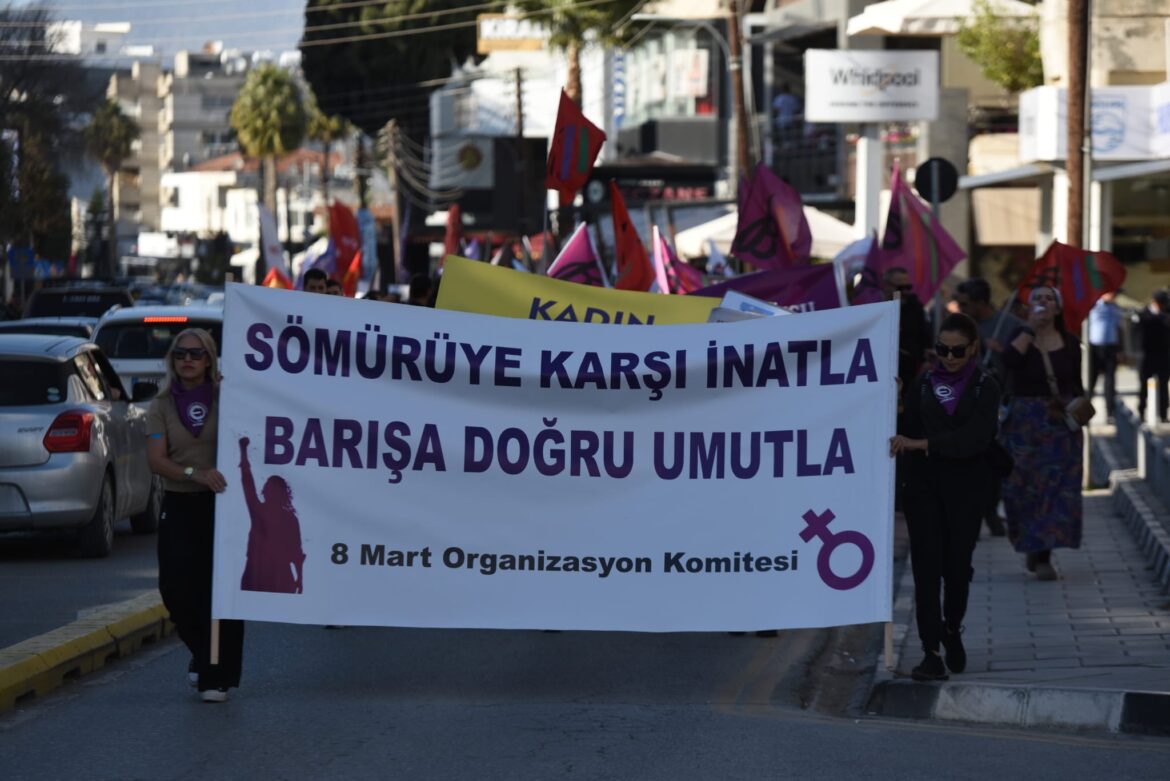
[{"x1": 889, "y1": 313, "x2": 999, "y2": 680}]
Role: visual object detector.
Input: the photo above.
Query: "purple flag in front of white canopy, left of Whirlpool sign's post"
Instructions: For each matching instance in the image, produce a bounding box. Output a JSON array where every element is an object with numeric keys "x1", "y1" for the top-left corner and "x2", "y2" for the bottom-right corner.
[{"x1": 731, "y1": 163, "x2": 812, "y2": 269}]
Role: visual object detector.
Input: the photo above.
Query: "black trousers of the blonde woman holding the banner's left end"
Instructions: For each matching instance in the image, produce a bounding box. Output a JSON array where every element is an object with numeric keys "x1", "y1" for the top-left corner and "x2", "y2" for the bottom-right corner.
[{"x1": 158, "y1": 491, "x2": 243, "y2": 691}]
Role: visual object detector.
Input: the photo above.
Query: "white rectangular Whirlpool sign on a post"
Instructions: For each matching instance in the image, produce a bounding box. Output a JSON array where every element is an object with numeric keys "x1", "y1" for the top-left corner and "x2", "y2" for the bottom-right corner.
[{"x1": 805, "y1": 49, "x2": 938, "y2": 122}]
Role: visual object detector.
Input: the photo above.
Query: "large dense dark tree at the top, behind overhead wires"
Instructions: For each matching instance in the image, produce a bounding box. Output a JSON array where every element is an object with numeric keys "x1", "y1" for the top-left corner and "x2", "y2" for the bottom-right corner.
[{"x1": 301, "y1": 0, "x2": 480, "y2": 138}]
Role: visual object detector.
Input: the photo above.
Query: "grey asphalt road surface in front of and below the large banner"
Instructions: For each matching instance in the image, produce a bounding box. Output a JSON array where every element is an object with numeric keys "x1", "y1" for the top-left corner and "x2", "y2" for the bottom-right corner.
[{"x1": 0, "y1": 623, "x2": 1170, "y2": 781}]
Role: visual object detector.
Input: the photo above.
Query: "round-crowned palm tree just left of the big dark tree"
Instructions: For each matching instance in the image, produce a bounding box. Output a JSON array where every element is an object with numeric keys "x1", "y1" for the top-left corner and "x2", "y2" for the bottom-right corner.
[{"x1": 230, "y1": 62, "x2": 309, "y2": 214}]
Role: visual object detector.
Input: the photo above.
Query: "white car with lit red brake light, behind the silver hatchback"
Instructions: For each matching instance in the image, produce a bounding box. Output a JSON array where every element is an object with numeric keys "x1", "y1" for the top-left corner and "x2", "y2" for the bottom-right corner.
[{"x1": 94, "y1": 305, "x2": 223, "y2": 388}]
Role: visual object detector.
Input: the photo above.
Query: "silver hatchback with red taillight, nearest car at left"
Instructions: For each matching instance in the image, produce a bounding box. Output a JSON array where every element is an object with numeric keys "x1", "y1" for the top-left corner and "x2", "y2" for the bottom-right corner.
[{"x1": 0, "y1": 334, "x2": 163, "y2": 557}]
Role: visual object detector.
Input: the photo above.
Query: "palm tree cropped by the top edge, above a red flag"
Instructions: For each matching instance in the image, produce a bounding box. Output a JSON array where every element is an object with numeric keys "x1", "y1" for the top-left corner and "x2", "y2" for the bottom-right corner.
[{"x1": 516, "y1": 0, "x2": 642, "y2": 105}]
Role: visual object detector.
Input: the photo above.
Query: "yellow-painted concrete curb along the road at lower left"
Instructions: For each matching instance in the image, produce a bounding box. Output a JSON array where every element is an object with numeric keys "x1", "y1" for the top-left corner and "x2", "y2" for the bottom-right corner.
[{"x1": 0, "y1": 594, "x2": 174, "y2": 712}]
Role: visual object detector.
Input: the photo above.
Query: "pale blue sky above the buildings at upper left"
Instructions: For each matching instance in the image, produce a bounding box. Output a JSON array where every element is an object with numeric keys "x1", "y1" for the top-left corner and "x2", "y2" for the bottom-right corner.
[{"x1": 24, "y1": 0, "x2": 305, "y2": 54}]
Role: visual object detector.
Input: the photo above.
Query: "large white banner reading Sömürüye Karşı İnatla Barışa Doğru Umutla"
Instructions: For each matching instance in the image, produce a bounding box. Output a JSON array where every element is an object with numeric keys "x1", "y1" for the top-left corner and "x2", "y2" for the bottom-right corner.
[{"x1": 213, "y1": 284, "x2": 897, "y2": 631}]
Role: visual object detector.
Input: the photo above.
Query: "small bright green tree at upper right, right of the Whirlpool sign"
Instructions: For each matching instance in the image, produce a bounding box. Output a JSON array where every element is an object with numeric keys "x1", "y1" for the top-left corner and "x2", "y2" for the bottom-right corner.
[{"x1": 958, "y1": 0, "x2": 1044, "y2": 95}]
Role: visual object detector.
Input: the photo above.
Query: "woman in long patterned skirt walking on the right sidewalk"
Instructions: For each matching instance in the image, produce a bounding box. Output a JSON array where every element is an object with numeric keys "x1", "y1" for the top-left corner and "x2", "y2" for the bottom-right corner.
[{"x1": 1003, "y1": 288, "x2": 1085, "y2": 580}]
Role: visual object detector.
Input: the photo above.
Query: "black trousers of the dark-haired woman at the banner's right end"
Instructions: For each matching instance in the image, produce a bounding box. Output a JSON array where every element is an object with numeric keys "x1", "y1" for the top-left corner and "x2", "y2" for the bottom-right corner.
[{"x1": 902, "y1": 469, "x2": 987, "y2": 651}]
